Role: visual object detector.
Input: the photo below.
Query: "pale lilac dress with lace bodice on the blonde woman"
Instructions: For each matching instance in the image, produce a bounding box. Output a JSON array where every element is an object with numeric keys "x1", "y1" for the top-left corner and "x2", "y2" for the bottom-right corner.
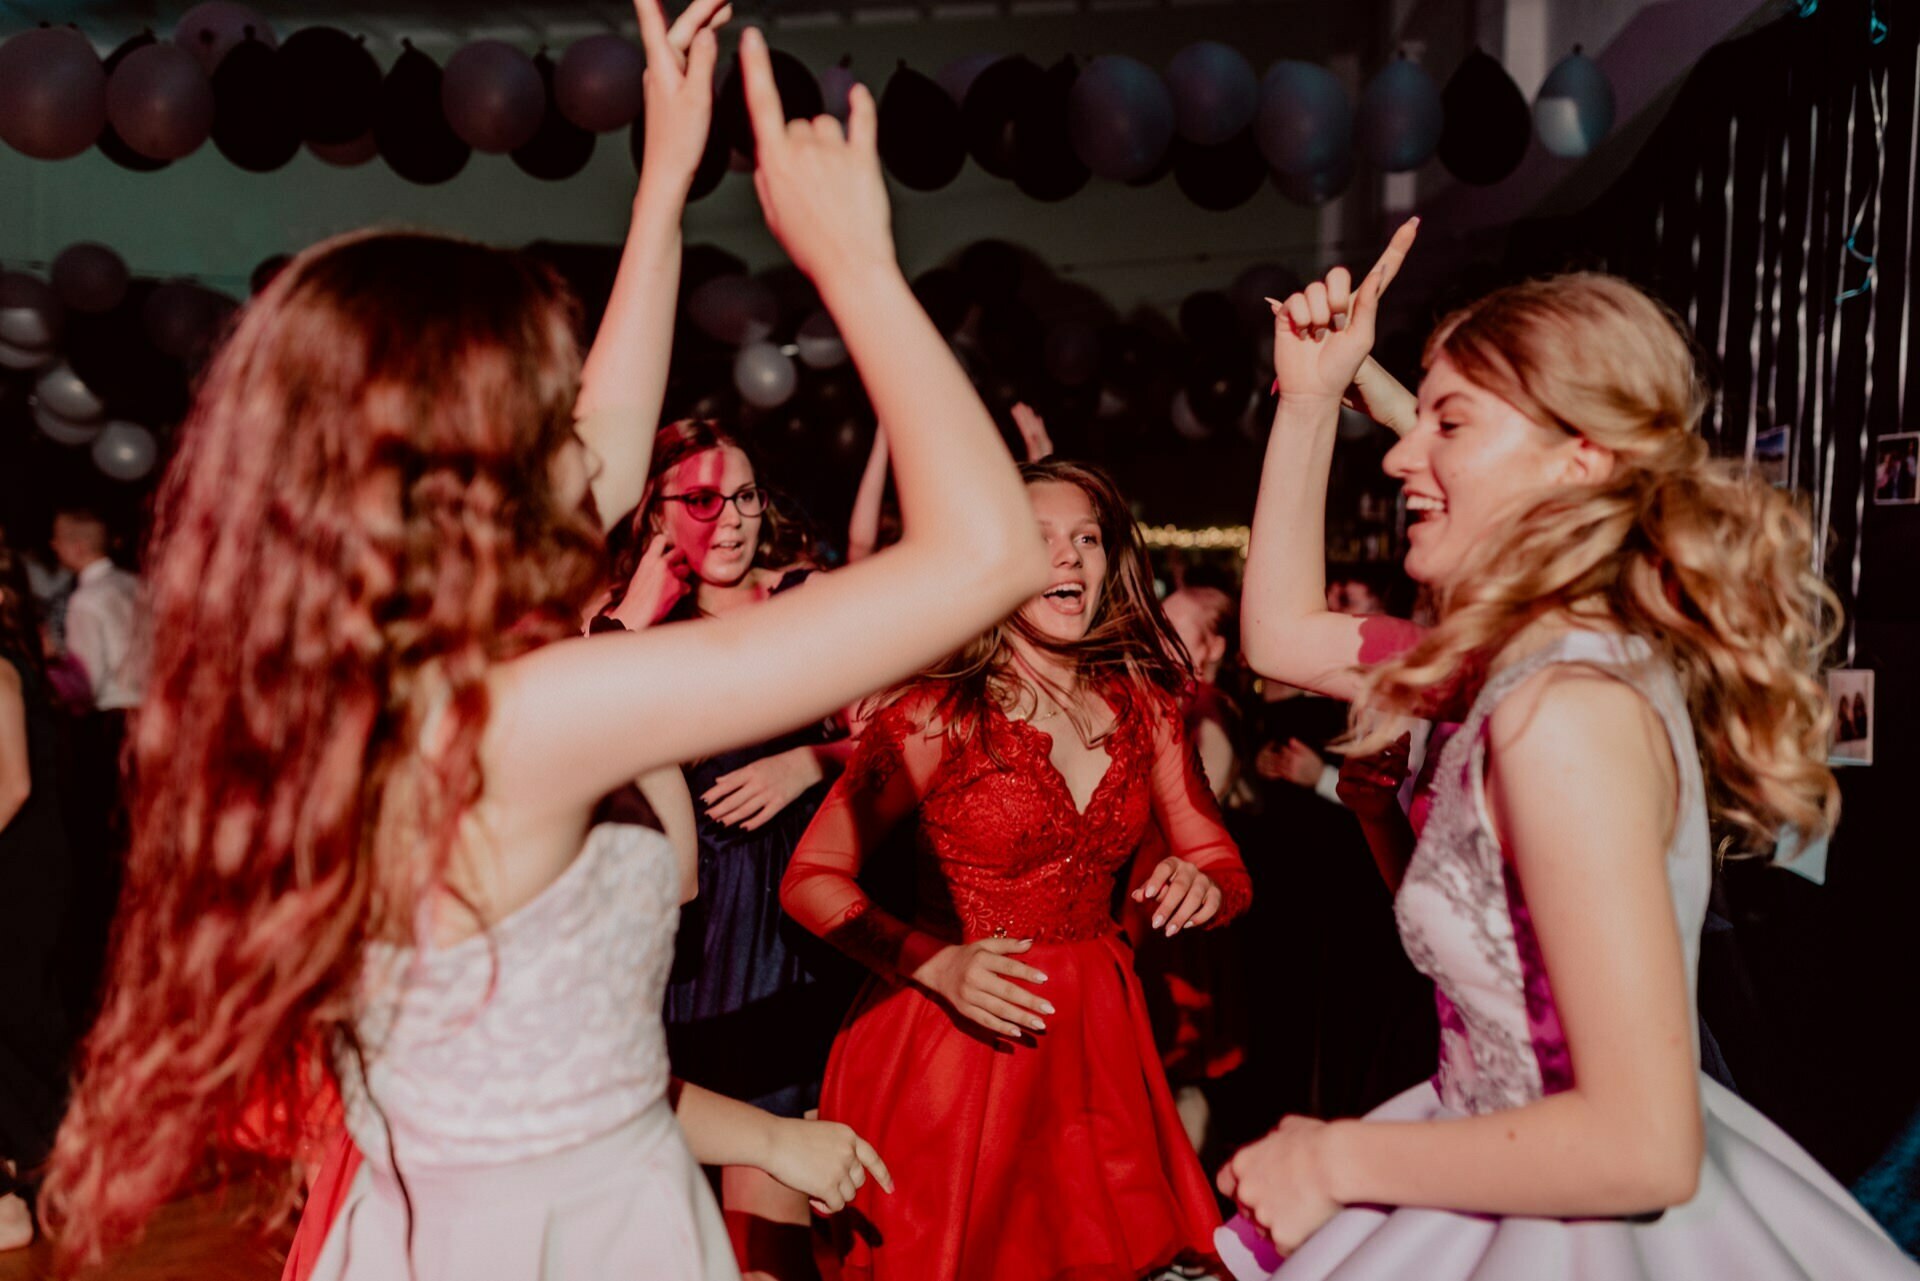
[{"x1": 1221, "y1": 632, "x2": 1920, "y2": 1281}]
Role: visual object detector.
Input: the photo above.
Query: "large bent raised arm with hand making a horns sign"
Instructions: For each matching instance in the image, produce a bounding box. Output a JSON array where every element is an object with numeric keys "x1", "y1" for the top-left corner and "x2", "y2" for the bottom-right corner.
[{"x1": 486, "y1": 31, "x2": 1046, "y2": 812}]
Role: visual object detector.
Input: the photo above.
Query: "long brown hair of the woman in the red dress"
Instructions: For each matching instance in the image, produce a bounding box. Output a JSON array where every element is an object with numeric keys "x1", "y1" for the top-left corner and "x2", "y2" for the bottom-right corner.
[{"x1": 876, "y1": 459, "x2": 1194, "y2": 751}]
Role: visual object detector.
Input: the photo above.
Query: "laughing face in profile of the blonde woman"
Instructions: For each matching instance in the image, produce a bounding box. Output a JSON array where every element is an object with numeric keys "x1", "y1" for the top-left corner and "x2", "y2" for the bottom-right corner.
[{"x1": 1386, "y1": 355, "x2": 1611, "y2": 588}]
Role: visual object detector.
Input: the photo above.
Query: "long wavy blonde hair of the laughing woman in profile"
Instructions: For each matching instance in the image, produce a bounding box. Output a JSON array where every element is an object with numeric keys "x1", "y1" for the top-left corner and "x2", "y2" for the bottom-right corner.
[{"x1": 1354, "y1": 273, "x2": 1839, "y2": 853}]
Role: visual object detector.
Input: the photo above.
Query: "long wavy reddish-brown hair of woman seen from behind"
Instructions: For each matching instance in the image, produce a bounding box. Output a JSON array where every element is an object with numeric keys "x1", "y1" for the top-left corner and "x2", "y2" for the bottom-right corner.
[{"x1": 42, "y1": 234, "x2": 601, "y2": 1262}]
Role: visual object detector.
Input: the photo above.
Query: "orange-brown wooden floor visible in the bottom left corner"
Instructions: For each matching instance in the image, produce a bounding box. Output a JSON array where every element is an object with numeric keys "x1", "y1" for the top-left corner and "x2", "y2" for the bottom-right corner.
[{"x1": 0, "y1": 1189, "x2": 292, "y2": 1281}]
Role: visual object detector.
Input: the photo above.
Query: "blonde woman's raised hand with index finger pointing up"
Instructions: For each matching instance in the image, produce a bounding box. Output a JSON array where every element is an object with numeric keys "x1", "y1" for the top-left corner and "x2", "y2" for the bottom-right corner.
[{"x1": 1267, "y1": 219, "x2": 1419, "y2": 399}]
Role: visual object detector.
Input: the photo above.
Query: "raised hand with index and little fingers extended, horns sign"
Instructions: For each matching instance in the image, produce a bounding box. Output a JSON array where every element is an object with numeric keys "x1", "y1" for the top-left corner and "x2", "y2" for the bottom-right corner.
[{"x1": 739, "y1": 27, "x2": 895, "y2": 284}]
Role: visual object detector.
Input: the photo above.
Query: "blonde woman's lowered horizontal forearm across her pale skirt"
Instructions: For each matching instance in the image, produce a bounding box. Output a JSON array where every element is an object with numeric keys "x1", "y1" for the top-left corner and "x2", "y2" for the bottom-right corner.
[{"x1": 1321, "y1": 1091, "x2": 1701, "y2": 1218}]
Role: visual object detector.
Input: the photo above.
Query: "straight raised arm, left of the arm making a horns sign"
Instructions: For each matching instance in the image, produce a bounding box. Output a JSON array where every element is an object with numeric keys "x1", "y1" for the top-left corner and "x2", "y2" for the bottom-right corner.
[{"x1": 574, "y1": 0, "x2": 733, "y2": 528}]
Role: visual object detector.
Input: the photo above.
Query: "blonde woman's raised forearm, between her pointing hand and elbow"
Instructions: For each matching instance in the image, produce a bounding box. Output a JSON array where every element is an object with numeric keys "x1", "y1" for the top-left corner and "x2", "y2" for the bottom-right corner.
[{"x1": 1240, "y1": 396, "x2": 1340, "y2": 686}]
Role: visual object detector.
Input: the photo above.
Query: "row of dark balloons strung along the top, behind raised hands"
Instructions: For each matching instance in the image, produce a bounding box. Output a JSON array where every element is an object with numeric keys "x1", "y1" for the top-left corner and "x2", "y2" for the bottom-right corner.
[{"x1": 0, "y1": 0, "x2": 1613, "y2": 200}]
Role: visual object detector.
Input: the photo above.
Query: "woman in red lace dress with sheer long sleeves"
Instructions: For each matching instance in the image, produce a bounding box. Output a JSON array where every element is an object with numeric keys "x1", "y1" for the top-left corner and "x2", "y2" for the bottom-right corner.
[{"x1": 781, "y1": 459, "x2": 1250, "y2": 1281}]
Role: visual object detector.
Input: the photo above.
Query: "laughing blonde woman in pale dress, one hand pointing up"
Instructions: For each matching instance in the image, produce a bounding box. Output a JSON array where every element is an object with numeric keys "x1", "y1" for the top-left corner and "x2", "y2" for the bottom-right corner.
[{"x1": 1219, "y1": 223, "x2": 1920, "y2": 1281}]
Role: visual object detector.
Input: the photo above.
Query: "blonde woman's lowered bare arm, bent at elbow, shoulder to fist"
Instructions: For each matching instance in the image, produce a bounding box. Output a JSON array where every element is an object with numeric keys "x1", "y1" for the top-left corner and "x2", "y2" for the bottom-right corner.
[{"x1": 1221, "y1": 672, "x2": 1703, "y2": 1250}]
